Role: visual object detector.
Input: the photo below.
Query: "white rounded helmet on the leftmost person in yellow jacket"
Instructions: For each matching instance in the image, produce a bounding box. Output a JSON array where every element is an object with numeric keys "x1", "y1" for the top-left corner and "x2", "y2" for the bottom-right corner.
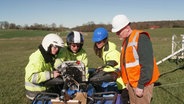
[{"x1": 41, "y1": 33, "x2": 64, "y2": 51}]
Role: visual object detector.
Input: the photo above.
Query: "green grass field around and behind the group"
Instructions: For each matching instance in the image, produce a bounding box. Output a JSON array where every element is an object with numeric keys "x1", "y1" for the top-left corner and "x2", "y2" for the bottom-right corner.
[{"x1": 0, "y1": 28, "x2": 184, "y2": 104}]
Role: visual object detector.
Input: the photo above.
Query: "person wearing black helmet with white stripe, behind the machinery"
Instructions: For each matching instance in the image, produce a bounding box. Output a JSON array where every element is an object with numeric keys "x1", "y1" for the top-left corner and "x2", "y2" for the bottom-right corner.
[{"x1": 54, "y1": 31, "x2": 88, "y2": 78}]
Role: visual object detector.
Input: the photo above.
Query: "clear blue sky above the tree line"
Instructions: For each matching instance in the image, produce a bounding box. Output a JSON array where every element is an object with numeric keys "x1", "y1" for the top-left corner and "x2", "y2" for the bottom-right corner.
[{"x1": 0, "y1": 0, "x2": 184, "y2": 28}]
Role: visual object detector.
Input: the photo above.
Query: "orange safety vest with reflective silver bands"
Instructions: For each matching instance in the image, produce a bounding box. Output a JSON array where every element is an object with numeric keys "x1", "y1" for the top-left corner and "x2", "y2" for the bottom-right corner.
[{"x1": 120, "y1": 30, "x2": 160, "y2": 87}]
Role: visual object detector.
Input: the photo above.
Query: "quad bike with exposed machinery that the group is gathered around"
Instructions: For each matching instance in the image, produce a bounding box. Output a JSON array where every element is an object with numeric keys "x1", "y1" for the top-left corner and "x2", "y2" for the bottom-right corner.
[{"x1": 33, "y1": 61, "x2": 117, "y2": 104}]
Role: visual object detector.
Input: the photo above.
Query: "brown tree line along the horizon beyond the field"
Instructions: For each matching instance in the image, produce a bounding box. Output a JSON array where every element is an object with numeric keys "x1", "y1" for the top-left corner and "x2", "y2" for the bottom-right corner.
[{"x1": 0, "y1": 20, "x2": 184, "y2": 32}]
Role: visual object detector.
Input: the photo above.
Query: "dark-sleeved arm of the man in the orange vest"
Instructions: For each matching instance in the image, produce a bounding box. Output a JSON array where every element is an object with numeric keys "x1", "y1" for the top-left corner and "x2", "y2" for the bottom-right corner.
[{"x1": 137, "y1": 34, "x2": 153, "y2": 89}]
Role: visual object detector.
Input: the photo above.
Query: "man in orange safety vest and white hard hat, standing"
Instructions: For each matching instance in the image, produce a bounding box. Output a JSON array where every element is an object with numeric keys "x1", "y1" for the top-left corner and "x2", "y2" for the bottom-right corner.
[{"x1": 111, "y1": 14, "x2": 159, "y2": 104}]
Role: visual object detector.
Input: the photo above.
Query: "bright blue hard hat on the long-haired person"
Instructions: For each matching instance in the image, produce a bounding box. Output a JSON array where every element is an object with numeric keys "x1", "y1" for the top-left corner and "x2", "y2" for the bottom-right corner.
[{"x1": 92, "y1": 27, "x2": 108, "y2": 42}]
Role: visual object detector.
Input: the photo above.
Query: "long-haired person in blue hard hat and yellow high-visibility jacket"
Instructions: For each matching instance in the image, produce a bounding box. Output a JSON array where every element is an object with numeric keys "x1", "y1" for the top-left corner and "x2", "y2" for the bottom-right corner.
[{"x1": 92, "y1": 27, "x2": 129, "y2": 104}]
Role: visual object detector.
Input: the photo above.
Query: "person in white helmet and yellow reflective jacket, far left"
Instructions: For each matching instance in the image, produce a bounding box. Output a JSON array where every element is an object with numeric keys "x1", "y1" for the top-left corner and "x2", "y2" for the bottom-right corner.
[{"x1": 25, "y1": 33, "x2": 64, "y2": 100}]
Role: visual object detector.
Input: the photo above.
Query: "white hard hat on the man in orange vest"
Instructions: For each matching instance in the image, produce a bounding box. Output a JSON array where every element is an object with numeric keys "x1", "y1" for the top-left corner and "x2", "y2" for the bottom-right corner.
[{"x1": 111, "y1": 14, "x2": 130, "y2": 32}]
